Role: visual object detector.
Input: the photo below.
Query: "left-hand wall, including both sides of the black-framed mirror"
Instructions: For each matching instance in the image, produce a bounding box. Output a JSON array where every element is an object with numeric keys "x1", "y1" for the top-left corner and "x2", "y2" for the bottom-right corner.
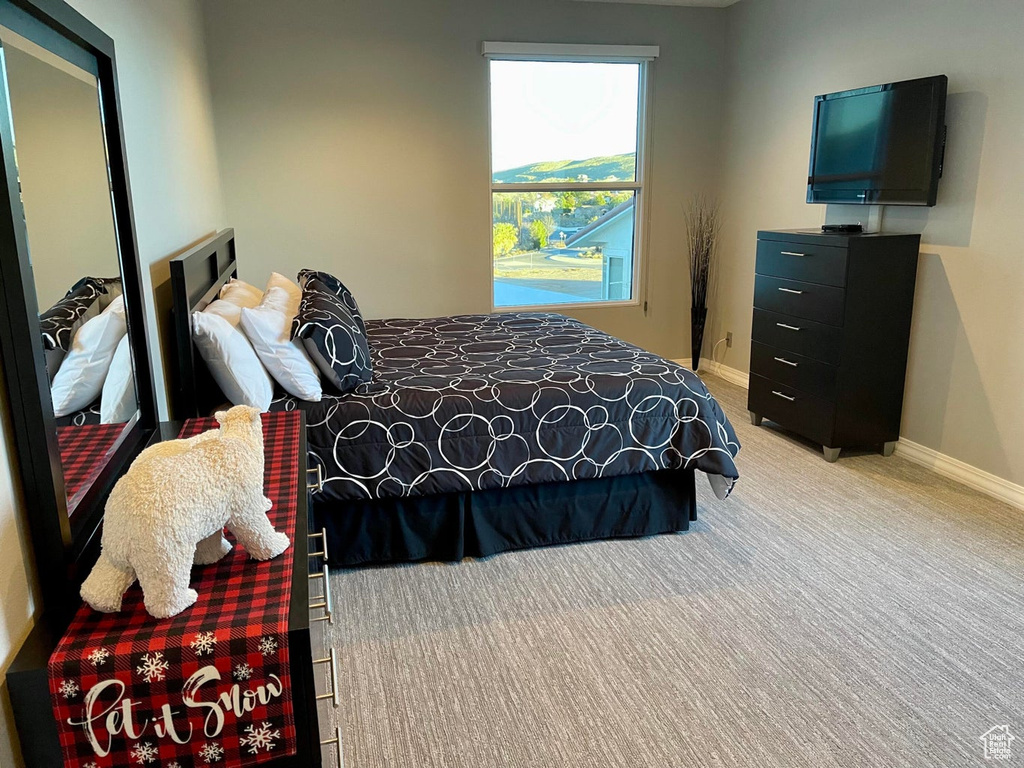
[{"x1": 0, "y1": 0, "x2": 224, "y2": 768}]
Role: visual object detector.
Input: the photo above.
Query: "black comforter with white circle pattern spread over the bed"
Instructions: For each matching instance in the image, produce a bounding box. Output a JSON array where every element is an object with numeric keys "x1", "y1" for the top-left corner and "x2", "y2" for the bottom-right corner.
[{"x1": 271, "y1": 312, "x2": 739, "y2": 500}]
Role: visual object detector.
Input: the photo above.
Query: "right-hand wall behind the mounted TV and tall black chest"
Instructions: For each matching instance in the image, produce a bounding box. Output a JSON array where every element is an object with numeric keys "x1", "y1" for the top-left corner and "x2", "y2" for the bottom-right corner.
[{"x1": 712, "y1": 0, "x2": 1024, "y2": 483}]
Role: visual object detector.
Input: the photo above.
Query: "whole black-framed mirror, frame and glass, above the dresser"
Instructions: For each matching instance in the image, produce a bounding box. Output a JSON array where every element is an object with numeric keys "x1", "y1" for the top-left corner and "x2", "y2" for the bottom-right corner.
[{"x1": 0, "y1": 0, "x2": 156, "y2": 618}]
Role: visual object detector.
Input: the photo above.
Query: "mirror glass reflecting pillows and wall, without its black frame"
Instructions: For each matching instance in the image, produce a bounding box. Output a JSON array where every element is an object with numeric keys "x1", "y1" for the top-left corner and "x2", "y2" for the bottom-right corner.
[{"x1": 0, "y1": 22, "x2": 138, "y2": 514}]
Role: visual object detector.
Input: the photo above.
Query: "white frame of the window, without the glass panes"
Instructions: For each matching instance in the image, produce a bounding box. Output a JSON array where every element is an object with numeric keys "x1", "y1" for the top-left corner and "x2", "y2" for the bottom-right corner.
[{"x1": 482, "y1": 42, "x2": 659, "y2": 312}]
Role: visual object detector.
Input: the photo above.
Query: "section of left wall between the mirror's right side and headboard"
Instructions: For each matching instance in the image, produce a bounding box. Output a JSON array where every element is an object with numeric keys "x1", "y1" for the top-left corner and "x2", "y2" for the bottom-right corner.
[{"x1": 71, "y1": 0, "x2": 225, "y2": 418}]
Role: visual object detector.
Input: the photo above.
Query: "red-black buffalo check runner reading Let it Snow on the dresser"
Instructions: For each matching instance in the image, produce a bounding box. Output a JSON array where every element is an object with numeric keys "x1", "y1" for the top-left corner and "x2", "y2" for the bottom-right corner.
[{"x1": 49, "y1": 413, "x2": 301, "y2": 768}]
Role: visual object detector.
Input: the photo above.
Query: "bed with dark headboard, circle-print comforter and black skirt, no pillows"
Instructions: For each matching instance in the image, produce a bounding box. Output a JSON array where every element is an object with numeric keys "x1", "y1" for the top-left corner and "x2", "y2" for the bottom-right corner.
[{"x1": 171, "y1": 230, "x2": 739, "y2": 565}]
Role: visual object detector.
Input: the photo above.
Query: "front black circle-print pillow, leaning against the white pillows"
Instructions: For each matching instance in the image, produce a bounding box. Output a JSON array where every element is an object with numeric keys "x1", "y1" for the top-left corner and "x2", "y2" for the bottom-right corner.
[{"x1": 292, "y1": 276, "x2": 373, "y2": 392}]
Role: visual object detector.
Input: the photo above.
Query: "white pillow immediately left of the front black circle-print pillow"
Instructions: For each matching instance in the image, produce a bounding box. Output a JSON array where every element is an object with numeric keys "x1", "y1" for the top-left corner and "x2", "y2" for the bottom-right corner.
[{"x1": 242, "y1": 279, "x2": 324, "y2": 402}]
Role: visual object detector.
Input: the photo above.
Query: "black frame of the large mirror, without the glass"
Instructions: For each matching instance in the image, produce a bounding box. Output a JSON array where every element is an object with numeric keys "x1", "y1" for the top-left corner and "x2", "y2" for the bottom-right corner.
[{"x1": 0, "y1": 0, "x2": 158, "y2": 621}]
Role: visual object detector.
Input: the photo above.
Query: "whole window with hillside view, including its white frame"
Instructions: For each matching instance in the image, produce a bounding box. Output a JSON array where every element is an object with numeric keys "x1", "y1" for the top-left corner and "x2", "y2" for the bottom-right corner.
[{"x1": 484, "y1": 43, "x2": 657, "y2": 309}]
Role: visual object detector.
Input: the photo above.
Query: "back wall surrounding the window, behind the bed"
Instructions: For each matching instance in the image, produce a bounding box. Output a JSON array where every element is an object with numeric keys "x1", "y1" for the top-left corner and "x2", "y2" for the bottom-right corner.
[{"x1": 197, "y1": 0, "x2": 726, "y2": 357}]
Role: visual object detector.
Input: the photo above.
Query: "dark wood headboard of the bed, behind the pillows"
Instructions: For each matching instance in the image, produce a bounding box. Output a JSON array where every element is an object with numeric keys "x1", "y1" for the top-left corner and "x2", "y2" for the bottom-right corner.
[{"x1": 171, "y1": 229, "x2": 238, "y2": 419}]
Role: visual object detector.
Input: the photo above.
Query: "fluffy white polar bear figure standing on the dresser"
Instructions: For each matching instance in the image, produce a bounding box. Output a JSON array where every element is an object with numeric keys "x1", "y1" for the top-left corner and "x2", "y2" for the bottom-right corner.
[{"x1": 82, "y1": 406, "x2": 290, "y2": 618}]
